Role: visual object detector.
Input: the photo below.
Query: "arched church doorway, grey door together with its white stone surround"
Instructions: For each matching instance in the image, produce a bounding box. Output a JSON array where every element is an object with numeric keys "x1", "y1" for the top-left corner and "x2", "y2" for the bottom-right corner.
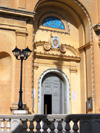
[{"x1": 38, "y1": 68, "x2": 70, "y2": 114}]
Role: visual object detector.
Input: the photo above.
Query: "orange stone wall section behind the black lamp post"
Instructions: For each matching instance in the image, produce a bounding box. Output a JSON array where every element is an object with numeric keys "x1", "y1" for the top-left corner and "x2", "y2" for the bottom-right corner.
[{"x1": 0, "y1": 8, "x2": 33, "y2": 114}]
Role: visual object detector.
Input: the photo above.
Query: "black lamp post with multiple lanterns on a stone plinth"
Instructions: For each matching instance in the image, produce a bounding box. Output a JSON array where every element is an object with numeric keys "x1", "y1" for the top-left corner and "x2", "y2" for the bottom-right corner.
[{"x1": 12, "y1": 46, "x2": 32, "y2": 110}]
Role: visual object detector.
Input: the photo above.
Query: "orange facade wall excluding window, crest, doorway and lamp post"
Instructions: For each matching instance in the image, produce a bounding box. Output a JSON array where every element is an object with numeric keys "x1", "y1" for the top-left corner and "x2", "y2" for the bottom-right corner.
[{"x1": 0, "y1": 0, "x2": 100, "y2": 113}]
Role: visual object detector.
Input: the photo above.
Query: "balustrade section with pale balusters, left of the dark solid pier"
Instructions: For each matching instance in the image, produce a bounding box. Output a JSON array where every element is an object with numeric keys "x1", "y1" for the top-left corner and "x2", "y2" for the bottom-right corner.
[{"x1": 0, "y1": 115, "x2": 78, "y2": 133}]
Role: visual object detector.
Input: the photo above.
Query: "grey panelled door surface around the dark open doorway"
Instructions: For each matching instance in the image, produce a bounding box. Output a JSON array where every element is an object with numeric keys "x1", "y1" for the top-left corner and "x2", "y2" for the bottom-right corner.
[{"x1": 42, "y1": 73, "x2": 63, "y2": 114}]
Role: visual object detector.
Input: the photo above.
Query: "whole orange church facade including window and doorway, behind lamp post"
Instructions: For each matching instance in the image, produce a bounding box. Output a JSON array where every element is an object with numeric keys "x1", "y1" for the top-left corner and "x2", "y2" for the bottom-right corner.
[{"x1": 0, "y1": 0, "x2": 100, "y2": 114}]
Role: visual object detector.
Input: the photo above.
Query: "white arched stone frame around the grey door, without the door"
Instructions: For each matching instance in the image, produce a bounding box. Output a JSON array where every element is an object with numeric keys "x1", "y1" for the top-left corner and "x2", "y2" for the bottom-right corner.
[{"x1": 38, "y1": 68, "x2": 70, "y2": 114}]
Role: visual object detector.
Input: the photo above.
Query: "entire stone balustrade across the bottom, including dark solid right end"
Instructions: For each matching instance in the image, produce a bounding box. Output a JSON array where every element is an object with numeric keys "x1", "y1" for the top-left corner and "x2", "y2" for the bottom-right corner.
[{"x1": 0, "y1": 114, "x2": 100, "y2": 133}]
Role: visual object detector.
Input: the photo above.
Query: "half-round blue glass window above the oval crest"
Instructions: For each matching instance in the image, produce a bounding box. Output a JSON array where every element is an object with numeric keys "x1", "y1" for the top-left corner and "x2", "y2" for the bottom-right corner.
[{"x1": 42, "y1": 17, "x2": 65, "y2": 29}]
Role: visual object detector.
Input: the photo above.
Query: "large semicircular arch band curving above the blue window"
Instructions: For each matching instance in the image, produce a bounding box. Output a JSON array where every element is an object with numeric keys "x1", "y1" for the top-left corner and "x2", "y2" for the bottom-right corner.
[{"x1": 34, "y1": 0, "x2": 93, "y2": 43}]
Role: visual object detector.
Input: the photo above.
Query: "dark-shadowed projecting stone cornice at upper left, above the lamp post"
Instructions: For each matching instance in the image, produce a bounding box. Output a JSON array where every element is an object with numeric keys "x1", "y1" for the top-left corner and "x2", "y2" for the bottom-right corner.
[{"x1": 0, "y1": 6, "x2": 35, "y2": 18}]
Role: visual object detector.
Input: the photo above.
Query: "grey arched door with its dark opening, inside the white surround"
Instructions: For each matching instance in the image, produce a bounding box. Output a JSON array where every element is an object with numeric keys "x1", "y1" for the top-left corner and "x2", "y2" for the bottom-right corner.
[{"x1": 42, "y1": 73, "x2": 64, "y2": 114}]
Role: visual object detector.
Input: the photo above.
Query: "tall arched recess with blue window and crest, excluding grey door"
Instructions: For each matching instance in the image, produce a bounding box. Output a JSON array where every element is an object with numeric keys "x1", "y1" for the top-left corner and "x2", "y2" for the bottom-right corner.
[{"x1": 33, "y1": 0, "x2": 93, "y2": 114}]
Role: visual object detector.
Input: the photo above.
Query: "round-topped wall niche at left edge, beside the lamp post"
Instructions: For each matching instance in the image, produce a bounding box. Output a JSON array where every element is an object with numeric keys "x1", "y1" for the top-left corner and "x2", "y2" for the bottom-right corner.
[{"x1": 0, "y1": 52, "x2": 11, "y2": 114}]
